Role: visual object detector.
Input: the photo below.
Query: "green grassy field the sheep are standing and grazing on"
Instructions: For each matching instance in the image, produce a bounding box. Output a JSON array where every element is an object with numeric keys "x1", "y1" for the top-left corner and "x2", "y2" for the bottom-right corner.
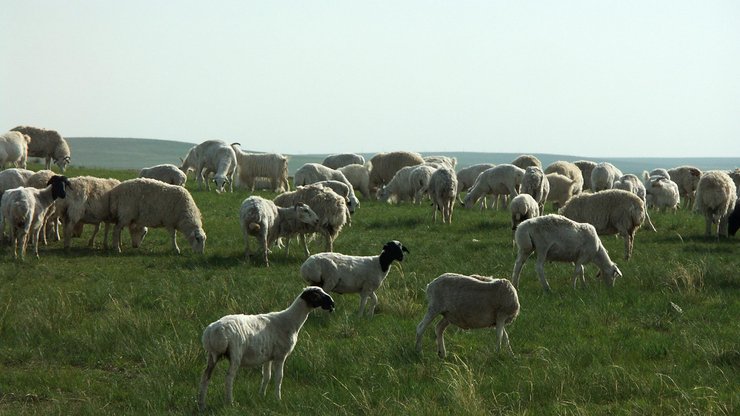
[{"x1": 0, "y1": 167, "x2": 740, "y2": 415}]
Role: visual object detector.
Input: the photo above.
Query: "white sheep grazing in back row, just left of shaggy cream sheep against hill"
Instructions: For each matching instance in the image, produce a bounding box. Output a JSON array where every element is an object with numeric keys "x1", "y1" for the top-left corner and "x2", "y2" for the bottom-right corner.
[{"x1": 180, "y1": 140, "x2": 236, "y2": 193}]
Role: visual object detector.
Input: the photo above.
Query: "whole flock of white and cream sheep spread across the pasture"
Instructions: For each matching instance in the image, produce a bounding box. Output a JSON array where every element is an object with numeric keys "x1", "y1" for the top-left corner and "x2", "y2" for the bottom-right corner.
[{"x1": 0, "y1": 127, "x2": 740, "y2": 409}]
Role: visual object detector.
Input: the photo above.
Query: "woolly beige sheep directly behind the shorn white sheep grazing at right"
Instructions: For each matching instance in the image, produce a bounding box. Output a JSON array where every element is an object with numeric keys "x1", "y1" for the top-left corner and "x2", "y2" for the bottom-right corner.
[{"x1": 559, "y1": 189, "x2": 645, "y2": 260}]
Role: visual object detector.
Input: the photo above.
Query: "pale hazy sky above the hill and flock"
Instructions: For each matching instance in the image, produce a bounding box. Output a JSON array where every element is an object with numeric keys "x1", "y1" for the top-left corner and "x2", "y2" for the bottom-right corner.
[{"x1": 0, "y1": 0, "x2": 740, "y2": 157}]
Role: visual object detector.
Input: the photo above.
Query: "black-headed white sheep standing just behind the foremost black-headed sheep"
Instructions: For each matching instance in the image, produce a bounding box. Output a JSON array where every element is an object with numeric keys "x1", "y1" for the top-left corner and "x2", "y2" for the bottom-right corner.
[{"x1": 301, "y1": 240, "x2": 410, "y2": 318}]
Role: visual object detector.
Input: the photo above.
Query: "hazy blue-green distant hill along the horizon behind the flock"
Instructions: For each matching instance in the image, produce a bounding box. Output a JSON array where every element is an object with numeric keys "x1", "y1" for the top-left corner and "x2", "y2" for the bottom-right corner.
[{"x1": 67, "y1": 137, "x2": 740, "y2": 175}]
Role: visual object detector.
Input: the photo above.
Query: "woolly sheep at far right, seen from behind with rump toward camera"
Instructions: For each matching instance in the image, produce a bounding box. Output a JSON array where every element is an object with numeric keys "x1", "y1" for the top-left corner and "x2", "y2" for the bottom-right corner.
[{"x1": 694, "y1": 170, "x2": 737, "y2": 237}]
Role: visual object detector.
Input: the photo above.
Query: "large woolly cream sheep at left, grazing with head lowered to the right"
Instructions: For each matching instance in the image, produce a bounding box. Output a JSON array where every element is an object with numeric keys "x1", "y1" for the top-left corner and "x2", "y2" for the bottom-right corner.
[{"x1": 109, "y1": 178, "x2": 206, "y2": 254}]
